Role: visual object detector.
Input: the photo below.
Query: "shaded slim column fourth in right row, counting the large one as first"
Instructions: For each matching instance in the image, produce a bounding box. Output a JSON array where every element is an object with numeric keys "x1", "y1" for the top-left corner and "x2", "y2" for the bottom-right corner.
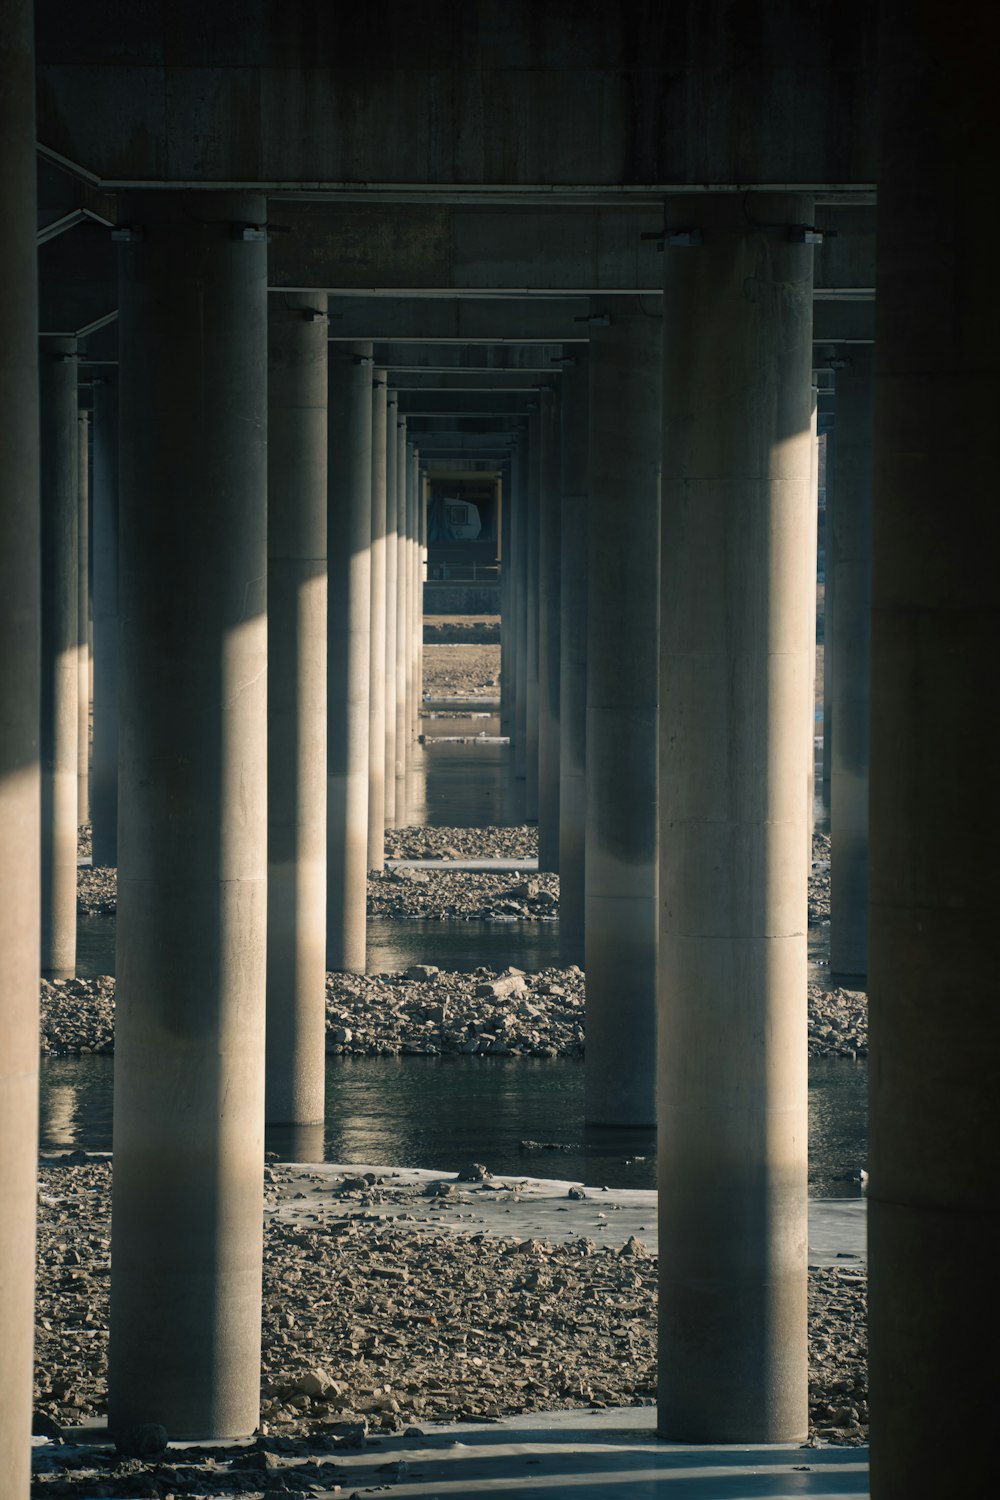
[{"x1": 538, "y1": 390, "x2": 562, "y2": 870}]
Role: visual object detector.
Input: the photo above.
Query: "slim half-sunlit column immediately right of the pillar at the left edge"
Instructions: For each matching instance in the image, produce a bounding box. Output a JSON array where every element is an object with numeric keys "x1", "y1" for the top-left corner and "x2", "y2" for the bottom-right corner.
[{"x1": 39, "y1": 339, "x2": 79, "y2": 978}]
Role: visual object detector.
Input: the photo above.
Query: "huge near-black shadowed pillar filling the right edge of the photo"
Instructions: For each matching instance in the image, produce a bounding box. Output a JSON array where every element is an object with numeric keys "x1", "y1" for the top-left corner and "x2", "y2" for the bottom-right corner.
[{"x1": 869, "y1": 0, "x2": 1000, "y2": 1500}]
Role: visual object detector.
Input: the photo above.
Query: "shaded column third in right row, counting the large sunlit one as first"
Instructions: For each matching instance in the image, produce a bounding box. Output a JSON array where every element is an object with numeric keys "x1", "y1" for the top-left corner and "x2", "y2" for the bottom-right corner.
[{"x1": 559, "y1": 344, "x2": 591, "y2": 965}]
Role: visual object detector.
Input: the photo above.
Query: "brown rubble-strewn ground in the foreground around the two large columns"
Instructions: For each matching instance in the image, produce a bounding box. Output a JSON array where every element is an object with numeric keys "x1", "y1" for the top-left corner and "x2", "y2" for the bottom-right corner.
[{"x1": 34, "y1": 1155, "x2": 868, "y2": 1497}]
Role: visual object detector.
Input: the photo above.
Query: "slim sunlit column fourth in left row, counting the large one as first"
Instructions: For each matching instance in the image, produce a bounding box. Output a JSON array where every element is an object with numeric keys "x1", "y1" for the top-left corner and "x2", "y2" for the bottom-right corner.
[{"x1": 367, "y1": 371, "x2": 387, "y2": 870}]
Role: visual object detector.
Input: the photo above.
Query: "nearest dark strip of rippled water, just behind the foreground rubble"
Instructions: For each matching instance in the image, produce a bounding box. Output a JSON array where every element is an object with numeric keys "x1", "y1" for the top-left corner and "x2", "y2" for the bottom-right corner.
[{"x1": 40, "y1": 1056, "x2": 868, "y2": 1197}]
